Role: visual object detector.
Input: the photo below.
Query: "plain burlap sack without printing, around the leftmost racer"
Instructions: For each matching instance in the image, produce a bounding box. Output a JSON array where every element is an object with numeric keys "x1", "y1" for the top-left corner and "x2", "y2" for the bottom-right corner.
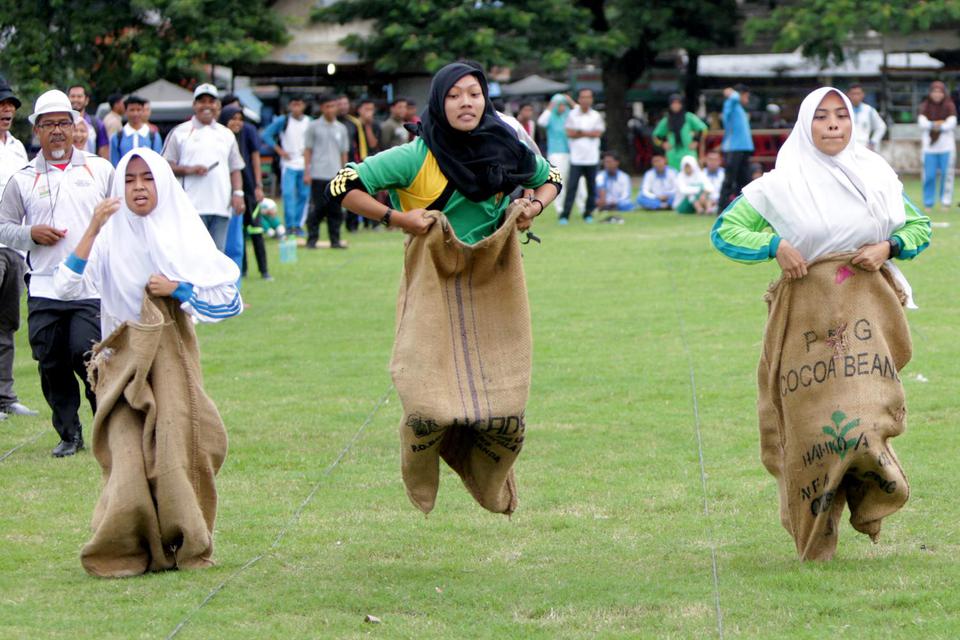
[{"x1": 80, "y1": 296, "x2": 227, "y2": 577}]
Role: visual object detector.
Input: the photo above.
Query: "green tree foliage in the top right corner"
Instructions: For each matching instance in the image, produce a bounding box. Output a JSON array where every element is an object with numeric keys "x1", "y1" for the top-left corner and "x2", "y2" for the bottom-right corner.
[{"x1": 744, "y1": 0, "x2": 960, "y2": 63}]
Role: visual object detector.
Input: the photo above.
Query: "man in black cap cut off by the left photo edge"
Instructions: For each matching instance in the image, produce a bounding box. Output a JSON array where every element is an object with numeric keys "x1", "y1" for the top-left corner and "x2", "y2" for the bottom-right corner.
[{"x1": 0, "y1": 78, "x2": 37, "y2": 420}]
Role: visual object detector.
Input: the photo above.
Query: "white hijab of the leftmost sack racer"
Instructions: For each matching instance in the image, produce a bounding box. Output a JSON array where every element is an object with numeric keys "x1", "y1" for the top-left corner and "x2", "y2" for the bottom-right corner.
[{"x1": 95, "y1": 147, "x2": 240, "y2": 323}]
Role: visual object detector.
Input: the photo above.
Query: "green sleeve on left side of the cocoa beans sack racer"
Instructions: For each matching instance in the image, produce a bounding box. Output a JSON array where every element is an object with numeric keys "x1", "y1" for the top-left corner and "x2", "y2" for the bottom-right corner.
[{"x1": 710, "y1": 196, "x2": 780, "y2": 264}]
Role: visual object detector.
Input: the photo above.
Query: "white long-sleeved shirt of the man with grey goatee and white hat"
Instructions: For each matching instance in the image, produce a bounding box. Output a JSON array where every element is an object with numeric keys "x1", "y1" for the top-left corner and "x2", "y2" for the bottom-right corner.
[{"x1": 0, "y1": 147, "x2": 113, "y2": 300}]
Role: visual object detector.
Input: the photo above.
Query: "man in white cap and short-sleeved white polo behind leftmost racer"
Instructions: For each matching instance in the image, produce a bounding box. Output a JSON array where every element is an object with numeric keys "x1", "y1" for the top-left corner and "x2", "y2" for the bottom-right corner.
[{"x1": 163, "y1": 84, "x2": 246, "y2": 251}]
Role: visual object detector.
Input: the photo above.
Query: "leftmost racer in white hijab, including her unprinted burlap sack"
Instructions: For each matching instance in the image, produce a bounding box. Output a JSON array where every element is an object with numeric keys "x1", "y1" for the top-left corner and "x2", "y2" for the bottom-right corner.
[{"x1": 54, "y1": 148, "x2": 243, "y2": 577}]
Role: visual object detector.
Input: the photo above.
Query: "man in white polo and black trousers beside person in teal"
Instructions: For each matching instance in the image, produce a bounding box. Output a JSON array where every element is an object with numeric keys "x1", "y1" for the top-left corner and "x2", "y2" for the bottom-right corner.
[{"x1": 560, "y1": 89, "x2": 606, "y2": 224}]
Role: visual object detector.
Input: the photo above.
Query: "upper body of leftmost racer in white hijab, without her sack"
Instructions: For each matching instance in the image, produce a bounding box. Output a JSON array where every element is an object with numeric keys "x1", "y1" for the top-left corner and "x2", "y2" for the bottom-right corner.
[{"x1": 54, "y1": 147, "x2": 243, "y2": 338}]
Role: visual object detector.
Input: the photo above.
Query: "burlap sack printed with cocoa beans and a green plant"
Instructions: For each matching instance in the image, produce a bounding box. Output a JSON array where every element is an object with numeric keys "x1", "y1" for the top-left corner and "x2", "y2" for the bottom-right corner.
[{"x1": 757, "y1": 254, "x2": 912, "y2": 560}]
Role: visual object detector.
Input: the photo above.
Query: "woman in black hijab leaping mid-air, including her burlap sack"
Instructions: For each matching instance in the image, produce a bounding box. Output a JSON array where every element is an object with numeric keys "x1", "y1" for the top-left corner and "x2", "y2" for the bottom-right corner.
[{"x1": 327, "y1": 63, "x2": 560, "y2": 514}]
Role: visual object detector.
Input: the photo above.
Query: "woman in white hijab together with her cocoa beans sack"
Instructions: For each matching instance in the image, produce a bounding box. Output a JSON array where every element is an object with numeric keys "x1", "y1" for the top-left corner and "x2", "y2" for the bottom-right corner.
[{"x1": 711, "y1": 87, "x2": 930, "y2": 560}]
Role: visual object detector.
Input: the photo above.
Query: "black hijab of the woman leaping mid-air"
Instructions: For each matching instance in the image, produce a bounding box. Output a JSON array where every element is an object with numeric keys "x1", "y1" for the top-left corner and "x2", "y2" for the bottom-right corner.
[{"x1": 417, "y1": 62, "x2": 537, "y2": 202}]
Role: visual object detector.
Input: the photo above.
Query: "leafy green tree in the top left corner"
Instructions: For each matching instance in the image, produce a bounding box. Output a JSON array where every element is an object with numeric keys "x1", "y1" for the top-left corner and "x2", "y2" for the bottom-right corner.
[{"x1": 0, "y1": 0, "x2": 286, "y2": 98}]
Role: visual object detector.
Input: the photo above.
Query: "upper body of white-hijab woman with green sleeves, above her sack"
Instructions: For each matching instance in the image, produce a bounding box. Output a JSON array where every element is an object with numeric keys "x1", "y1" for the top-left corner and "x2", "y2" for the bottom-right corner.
[{"x1": 711, "y1": 87, "x2": 930, "y2": 285}]
